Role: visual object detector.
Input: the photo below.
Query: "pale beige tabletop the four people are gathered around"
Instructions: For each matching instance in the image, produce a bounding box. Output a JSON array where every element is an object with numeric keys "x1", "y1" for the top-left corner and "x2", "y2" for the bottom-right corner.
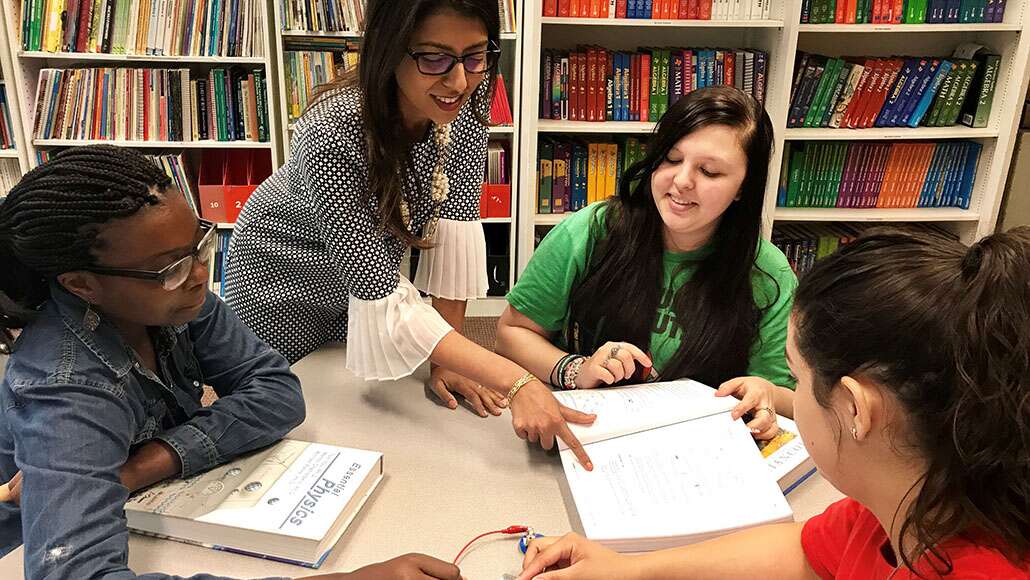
[{"x1": 0, "y1": 346, "x2": 842, "y2": 580}]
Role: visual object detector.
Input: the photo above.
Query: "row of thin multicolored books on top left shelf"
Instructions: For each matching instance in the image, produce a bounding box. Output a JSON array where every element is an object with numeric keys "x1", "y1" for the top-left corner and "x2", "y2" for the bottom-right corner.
[{"x1": 21, "y1": 0, "x2": 265, "y2": 57}]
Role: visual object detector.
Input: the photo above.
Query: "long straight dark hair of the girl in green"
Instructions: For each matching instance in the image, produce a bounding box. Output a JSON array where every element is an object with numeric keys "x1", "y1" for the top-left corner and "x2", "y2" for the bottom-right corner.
[{"x1": 565, "y1": 87, "x2": 776, "y2": 386}]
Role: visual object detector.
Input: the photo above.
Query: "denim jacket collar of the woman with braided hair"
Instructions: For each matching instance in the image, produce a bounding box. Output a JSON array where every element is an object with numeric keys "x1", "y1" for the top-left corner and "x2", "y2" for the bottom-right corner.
[{"x1": 50, "y1": 282, "x2": 186, "y2": 377}]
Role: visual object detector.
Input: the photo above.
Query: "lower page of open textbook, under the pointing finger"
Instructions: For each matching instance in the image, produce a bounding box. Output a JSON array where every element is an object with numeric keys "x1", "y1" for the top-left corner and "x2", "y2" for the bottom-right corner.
[{"x1": 560, "y1": 413, "x2": 793, "y2": 551}]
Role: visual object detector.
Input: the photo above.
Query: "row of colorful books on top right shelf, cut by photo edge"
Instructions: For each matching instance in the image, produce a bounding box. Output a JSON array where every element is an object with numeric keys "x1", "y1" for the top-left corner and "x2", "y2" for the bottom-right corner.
[{"x1": 801, "y1": 0, "x2": 1008, "y2": 24}]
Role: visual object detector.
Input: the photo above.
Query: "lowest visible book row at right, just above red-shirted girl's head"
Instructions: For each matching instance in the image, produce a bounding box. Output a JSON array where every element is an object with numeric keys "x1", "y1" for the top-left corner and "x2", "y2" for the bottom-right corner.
[{"x1": 771, "y1": 223, "x2": 958, "y2": 276}]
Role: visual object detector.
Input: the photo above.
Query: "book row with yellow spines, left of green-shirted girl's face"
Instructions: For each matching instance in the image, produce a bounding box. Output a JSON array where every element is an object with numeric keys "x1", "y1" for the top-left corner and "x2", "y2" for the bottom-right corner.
[{"x1": 537, "y1": 137, "x2": 645, "y2": 213}]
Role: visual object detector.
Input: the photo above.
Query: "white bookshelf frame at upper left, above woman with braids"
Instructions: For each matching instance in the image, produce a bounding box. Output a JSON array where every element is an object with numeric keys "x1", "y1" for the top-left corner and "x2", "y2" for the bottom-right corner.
[{"x1": 0, "y1": 0, "x2": 282, "y2": 169}]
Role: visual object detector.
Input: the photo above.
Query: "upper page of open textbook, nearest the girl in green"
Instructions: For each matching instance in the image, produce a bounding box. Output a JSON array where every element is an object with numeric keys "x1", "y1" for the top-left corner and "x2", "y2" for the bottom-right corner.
[{"x1": 554, "y1": 380, "x2": 741, "y2": 453}]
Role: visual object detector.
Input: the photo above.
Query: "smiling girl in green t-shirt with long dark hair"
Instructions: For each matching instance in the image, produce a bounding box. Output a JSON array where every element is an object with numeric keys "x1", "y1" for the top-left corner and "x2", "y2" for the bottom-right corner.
[{"x1": 497, "y1": 87, "x2": 797, "y2": 438}]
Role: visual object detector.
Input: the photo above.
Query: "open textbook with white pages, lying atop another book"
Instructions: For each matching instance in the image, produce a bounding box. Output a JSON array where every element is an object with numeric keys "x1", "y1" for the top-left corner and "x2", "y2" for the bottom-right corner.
[{"x1": 555, "y1": 380, "x2": 814, "y2": 551}]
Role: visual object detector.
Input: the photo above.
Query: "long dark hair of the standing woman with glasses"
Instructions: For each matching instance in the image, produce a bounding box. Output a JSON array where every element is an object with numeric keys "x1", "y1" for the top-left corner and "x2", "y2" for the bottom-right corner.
[{"x1": 309, "y1": 0, "x2": 501, "y2": 248}]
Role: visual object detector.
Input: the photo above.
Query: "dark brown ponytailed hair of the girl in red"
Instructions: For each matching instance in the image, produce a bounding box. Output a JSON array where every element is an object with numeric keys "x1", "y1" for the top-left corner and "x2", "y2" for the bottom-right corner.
[{"x1": 794, "y1": 227, "x2": 1030, "y2": 575}]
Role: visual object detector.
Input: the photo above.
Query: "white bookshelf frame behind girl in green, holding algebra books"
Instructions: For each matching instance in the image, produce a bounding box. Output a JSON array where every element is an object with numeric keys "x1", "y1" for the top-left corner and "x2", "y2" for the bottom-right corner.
[{"x1": 517, "y1": 0, "x2": 1030, "y2": 273}]
